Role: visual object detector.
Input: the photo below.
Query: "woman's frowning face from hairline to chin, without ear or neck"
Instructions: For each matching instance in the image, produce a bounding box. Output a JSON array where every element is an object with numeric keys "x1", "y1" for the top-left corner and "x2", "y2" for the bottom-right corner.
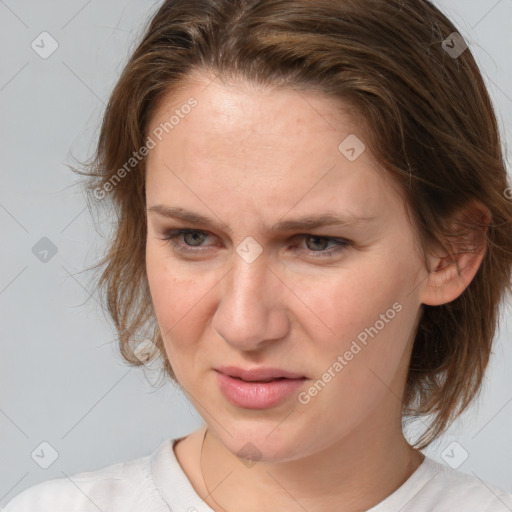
[{"x1": 146, "y1": 75, "x2": 426, "y2": 461}]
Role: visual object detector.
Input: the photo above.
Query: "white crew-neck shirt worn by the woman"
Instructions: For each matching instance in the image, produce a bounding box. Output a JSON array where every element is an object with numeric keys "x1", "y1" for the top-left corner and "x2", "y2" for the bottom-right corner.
[{"x1": 3, "y1": 439, "x2": 512, "y2": 512}]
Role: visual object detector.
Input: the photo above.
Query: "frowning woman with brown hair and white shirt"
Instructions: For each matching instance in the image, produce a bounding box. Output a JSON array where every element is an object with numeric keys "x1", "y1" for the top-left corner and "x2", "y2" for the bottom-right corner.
[{"x1": 6, "y1": 0, "x2": 512, "y2": 512}]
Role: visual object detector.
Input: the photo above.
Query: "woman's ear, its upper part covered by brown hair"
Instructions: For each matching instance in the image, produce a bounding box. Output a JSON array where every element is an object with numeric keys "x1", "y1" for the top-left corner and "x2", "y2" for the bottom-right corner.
[{"x1": 421, "y1": 200, "x2": 492, "y2": 306}]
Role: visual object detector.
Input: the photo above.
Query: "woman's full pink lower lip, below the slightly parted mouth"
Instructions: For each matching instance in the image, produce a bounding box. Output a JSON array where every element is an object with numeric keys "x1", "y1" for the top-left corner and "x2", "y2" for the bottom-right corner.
[{"x1": 217, "y1": 372, "x2": 307, "y2": 409}]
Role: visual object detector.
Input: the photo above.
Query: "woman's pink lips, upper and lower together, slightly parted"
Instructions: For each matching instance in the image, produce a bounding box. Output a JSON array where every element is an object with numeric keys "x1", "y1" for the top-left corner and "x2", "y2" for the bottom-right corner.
[{"x1": 216, "y1": 367, "x2": 308, "y2": 409}]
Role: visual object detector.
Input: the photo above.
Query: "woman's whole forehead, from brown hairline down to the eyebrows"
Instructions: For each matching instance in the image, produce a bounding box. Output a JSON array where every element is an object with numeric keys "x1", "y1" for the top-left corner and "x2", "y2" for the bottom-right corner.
[{"x1": 146, "y1": 75, "x2": 404, "y2": 226}]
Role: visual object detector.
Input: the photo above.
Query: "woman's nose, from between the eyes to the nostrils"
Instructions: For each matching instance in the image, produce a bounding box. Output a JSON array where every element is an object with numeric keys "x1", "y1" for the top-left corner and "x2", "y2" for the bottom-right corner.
[{"x1": 212, "y1": 254, "x2": 291, "y2": 351}]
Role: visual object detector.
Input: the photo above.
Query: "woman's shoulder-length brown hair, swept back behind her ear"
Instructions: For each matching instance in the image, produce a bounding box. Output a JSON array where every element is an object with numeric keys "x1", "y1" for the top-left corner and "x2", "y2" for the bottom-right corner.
[{"x1": 78, "y1": 0, "x2": 512, "y2": 449}]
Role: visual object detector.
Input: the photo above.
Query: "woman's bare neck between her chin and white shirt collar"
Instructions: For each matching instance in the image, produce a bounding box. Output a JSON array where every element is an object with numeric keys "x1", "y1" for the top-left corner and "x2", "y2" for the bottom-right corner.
[{"x1": 201, "y1": 416, "x2": 424, "y2": 512}]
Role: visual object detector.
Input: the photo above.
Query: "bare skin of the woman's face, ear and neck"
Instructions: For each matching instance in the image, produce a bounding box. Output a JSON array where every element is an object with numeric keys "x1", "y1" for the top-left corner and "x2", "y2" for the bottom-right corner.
[{"x1": 146, "y1": 76, "x2": 481, "y2": 512}]
